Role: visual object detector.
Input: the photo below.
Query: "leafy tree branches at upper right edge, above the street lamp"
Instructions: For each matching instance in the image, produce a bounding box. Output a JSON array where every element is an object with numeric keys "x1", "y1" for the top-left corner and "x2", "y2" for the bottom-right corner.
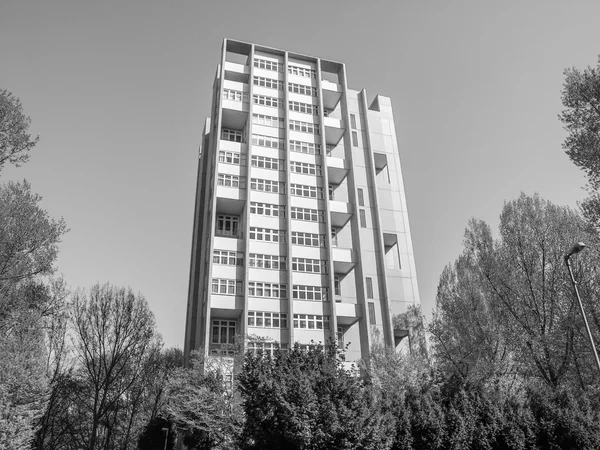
[{"x1": 559, "y1": 56, "x2": 600, "y2": 227}]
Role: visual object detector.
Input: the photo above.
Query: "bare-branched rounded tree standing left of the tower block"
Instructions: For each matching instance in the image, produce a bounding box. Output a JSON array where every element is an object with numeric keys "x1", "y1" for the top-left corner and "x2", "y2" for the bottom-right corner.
[{"x1": 72, "y1": 284, "x2": 161, "y2": 450}]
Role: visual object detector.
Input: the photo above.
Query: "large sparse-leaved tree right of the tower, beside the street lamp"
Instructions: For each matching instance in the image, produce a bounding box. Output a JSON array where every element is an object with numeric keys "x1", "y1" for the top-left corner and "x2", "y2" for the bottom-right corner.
[{"x1": 431, "y1": 194, "x2": 598, "y2": 389}]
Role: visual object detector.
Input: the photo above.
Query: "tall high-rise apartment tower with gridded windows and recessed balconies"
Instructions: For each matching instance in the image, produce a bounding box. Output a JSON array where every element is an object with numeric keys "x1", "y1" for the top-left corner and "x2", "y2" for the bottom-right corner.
[{"x1": 185, "y1": 39, "x2": 419, "y2": 361}]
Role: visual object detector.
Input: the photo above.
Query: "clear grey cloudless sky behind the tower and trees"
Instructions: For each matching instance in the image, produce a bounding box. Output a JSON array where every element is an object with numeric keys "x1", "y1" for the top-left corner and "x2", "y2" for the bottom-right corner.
[{"x1": 0, "y1": 0, "x2": 600, "y2": 347}]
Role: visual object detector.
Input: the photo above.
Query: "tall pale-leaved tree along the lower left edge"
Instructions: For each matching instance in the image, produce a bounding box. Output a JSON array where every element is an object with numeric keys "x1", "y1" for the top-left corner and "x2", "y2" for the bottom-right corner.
[{"x1": 0, "y1": 178, "x2": 67, "y2": 448}]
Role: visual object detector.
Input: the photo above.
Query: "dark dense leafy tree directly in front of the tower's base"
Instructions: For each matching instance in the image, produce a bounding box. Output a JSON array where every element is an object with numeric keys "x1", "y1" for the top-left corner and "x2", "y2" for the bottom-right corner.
[{"x1": 239, "y1": 345, "x2": 392, "y2": 449}]
